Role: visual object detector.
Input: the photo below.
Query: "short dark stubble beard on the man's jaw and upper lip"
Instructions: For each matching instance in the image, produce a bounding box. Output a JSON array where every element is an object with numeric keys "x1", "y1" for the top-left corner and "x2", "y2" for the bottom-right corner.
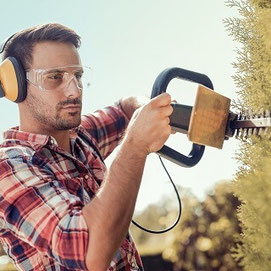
[{"x1": 26, "y1": 92, "x2": 82, "y2": 131}]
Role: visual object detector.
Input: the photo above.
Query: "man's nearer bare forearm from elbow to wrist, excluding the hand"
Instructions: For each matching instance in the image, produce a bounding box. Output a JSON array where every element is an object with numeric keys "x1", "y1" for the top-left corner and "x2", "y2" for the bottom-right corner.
[{"x1": 83, "y1": 139, "x2": 146, "y2": 271}]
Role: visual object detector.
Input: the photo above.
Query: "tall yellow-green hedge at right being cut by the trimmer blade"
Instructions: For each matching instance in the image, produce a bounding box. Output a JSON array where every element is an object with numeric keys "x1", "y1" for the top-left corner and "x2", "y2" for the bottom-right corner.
[{"x1": 225, "y1": 0, "x2": 271, "y2": 271}]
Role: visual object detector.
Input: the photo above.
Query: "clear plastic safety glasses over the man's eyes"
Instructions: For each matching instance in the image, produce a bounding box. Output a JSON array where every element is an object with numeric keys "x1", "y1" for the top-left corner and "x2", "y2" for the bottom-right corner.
[{"x1": 26, "y1": 65, "x2": 91, "y2": 91}]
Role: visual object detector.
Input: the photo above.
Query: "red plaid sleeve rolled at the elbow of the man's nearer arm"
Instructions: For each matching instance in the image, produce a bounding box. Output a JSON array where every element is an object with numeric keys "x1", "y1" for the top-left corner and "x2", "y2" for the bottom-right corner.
[{"x1": 0, "y1": 157, "x2": 88, "y2": 270}]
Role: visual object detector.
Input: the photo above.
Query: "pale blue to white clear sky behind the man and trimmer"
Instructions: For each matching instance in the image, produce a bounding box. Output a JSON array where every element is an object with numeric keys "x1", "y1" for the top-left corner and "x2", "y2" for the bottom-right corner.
[{"x1": 0, "y1": 0, "x2": 242, "y2": 211}]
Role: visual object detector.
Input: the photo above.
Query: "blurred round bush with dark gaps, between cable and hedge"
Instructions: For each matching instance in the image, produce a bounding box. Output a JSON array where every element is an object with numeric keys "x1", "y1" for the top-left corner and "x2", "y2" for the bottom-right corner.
[{"x1": 164, "y1": 183, "x2": 241, "y2": 271}]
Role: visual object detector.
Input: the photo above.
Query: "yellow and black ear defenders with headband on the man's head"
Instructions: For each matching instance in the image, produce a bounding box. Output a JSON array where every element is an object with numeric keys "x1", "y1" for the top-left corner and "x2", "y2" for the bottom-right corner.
[{"x1": 0, "y1": 35, "x2": 27, "y2": 103}]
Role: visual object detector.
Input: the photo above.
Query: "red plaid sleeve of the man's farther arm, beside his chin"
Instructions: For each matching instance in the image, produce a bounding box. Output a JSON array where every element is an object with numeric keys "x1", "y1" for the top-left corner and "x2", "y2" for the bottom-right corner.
[{"x1": 81, "y1": 102, "x2": 129, "y2": 159}]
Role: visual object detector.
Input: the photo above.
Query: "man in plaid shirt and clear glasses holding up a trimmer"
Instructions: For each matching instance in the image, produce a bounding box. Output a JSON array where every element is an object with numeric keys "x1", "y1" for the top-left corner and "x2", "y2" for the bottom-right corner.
[{"x1": 0, "y1": 24, "x2": 172, "y2": 271}]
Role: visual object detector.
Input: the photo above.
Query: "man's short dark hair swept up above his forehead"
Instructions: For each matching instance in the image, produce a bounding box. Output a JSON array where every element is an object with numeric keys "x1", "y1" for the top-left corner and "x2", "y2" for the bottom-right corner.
[{"x1": 3, "y1": 23, "x2": 81, "y2": 69}]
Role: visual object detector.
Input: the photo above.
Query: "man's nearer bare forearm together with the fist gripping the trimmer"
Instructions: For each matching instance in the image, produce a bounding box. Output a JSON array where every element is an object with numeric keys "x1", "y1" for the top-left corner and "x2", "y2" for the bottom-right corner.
[{"x1": 83, "y1": 93, "x2": 173, "y2": 271}]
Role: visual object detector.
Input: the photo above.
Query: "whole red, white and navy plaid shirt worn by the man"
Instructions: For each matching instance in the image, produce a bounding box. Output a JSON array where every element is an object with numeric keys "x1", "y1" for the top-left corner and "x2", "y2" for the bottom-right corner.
[{"x1": 0, "y1": 105, "x2": 143, "y2": 271}]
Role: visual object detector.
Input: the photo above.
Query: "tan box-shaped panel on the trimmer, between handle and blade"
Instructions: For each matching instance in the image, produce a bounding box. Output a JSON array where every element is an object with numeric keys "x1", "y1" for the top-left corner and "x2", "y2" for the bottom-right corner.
[{"x1": 188, "y1": 85, "x2": 231, "y2": 149}]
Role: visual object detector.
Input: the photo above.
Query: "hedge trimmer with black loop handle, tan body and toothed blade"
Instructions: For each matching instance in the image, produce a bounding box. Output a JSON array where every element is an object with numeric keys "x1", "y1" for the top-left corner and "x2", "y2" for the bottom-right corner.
[{"x1": 151, "y1": 68, "x2": 271, "y2": 167}]
